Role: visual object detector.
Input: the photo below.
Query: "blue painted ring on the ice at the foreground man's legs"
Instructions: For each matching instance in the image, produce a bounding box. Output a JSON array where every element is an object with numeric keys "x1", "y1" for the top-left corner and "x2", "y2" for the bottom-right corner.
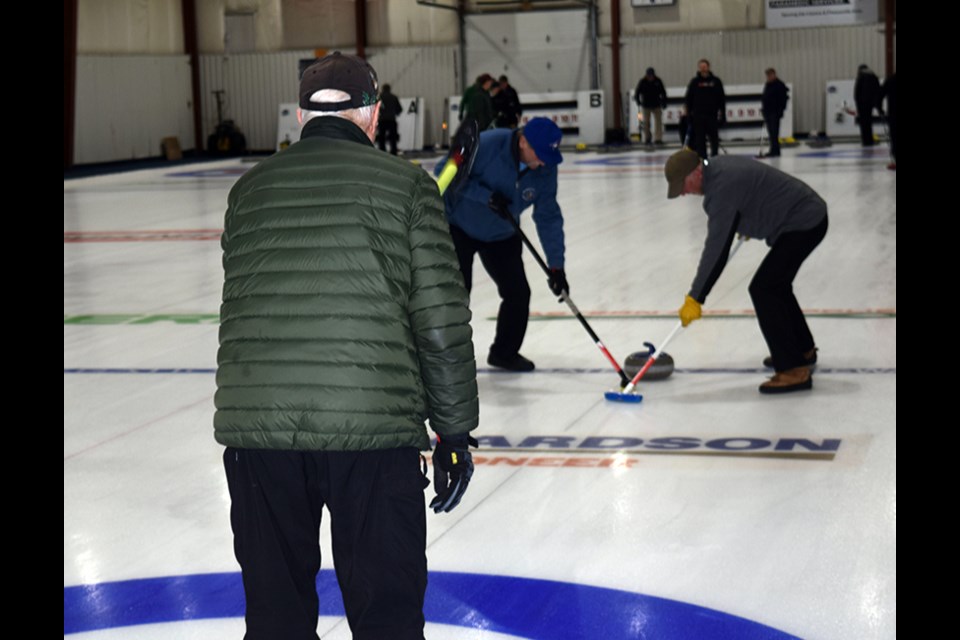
[{"x1": 63, "y1": 569, "x2": 796, "y2": 640}]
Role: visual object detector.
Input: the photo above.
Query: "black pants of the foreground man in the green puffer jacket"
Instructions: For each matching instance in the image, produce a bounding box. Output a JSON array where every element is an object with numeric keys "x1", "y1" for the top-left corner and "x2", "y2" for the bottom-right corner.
[{"x1": 223, "y1": 447, "x2": 427, "y2": 640}]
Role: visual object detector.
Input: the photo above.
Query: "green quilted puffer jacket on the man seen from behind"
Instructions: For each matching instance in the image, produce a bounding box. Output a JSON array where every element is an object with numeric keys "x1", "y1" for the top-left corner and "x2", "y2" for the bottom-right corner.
[{"x1": 214, "y1": 117, "x2": 478, "y2": 451}]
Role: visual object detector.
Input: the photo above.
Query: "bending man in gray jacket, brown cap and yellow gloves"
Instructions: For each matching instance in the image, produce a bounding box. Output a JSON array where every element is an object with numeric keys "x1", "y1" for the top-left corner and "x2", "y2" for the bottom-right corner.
[{"x1": 664, "y1": 149, "x2": 827, "y2": 393}]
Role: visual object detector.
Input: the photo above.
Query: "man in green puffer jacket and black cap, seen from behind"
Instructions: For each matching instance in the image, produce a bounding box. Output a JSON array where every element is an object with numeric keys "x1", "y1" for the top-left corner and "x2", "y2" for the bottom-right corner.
[{"x1": 214, "y1": 52, "x2": 478, "y2": 640}]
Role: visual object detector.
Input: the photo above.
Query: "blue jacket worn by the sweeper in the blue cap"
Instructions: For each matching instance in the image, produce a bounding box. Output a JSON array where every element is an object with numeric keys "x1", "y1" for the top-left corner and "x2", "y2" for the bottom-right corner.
[{"x1": 434, "y1": 129, "x2": 564, "y2": 269}]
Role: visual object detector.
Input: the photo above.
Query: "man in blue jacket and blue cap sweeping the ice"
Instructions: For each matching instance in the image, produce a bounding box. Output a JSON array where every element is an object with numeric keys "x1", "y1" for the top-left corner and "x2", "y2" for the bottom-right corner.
[{"x1": 440, "y1": 118, "x2": 569, "y2": 371}]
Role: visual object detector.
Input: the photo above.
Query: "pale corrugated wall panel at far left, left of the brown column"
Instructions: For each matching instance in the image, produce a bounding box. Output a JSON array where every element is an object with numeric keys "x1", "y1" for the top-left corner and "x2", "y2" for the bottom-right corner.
[{"x1": 74, "y1": 55, "x2": 193, "y2": 164}]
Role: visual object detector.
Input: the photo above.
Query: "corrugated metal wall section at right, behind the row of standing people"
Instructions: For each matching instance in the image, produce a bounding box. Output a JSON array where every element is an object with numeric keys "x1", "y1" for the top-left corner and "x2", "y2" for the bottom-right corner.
[{"x1": 601, "y1": 24, "x2": 884, "y2": 132}]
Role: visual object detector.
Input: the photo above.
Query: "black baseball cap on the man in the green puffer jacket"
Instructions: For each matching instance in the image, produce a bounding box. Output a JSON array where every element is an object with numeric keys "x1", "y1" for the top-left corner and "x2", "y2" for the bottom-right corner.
[{"x1": 300, "y1": 51, "x2": 380, "y2": 111}]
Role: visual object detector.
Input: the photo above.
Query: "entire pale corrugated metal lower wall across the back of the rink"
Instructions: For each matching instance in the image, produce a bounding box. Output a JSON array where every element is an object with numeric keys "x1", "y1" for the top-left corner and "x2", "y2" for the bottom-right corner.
[{"x1": 75, "y1": 25, "x2": 884, "y2": 164}]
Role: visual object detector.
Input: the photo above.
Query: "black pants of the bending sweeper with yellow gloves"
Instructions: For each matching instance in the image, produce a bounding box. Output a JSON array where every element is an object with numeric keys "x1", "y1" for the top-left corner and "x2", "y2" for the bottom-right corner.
[{"x1": 750, "y1": 215, "x2": 827, "y2": 371}]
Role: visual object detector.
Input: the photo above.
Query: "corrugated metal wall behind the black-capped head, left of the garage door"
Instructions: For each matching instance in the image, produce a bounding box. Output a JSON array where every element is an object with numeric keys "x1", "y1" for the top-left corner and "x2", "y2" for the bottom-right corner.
[{"x1": 200, "y1": 46, "x2": 457, "y2": 149}]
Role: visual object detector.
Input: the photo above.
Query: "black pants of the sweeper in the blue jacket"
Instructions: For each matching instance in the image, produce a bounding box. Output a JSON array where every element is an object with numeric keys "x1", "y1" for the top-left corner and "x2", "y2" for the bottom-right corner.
[{"x1": 450, "y1": 225, "x2": 530, "y2": 358}]
